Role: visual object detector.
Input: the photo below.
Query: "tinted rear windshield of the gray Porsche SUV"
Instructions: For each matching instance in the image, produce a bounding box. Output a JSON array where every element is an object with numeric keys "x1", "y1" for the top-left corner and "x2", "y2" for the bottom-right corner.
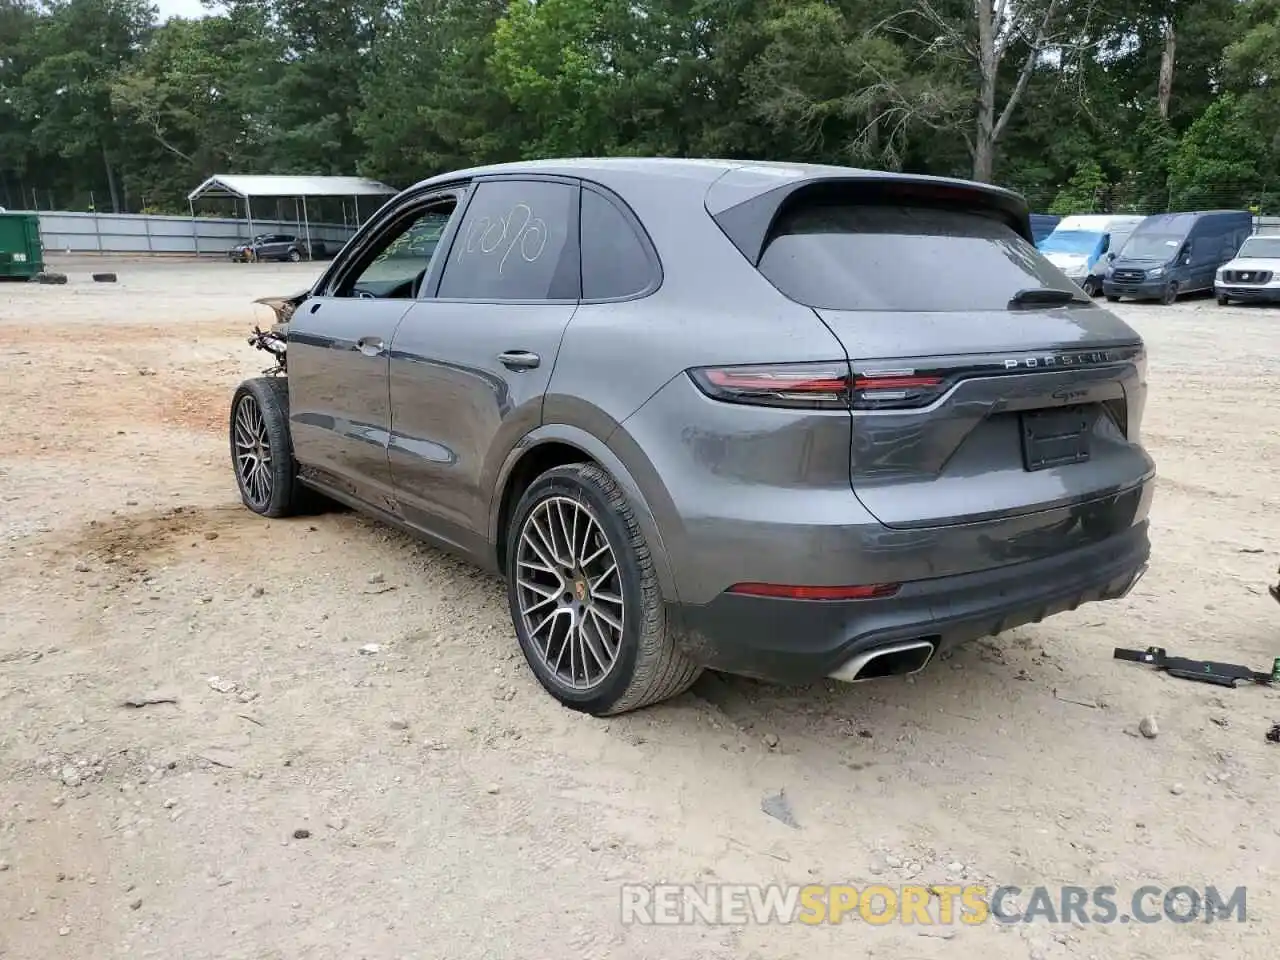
[{"x1": 759, "y1": 204, "x2": 1079, "y2": 312}]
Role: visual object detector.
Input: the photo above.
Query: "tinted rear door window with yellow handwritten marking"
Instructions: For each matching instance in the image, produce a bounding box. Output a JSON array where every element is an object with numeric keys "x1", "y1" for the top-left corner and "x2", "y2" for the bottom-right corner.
[{"x1": 436, "y1": 180, "x2": 581, "y2": 300}]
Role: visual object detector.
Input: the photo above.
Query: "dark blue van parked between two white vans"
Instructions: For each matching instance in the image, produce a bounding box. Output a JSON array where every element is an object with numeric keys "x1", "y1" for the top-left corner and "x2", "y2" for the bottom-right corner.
[{"x1": 1102, "y1": 210, "x2": 1253, "y2": 303}]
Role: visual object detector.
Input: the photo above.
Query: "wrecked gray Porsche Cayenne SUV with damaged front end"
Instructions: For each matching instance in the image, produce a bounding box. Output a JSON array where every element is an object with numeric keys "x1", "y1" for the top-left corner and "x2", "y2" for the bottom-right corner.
[{"x1": 230, "y1": 159, "x2": 1155, "y2": 714}]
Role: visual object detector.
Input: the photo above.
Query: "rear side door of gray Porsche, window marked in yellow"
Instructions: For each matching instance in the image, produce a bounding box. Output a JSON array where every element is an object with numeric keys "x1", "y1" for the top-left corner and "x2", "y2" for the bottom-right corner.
[{"x1": 378, "y1": 177, "x2": 581, "y2": 552}]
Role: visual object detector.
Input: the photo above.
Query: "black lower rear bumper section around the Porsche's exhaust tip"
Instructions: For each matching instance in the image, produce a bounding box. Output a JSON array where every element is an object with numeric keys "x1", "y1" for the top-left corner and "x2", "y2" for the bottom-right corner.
[{"x1": 669, "y1": 520, "x2": 1151, "y2": 684}]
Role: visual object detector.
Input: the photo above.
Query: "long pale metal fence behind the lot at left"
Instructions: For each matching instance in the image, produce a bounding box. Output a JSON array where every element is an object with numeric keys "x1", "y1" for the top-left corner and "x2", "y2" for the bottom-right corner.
[{"x1": 21, "y1": 211, "x2": 356, "y2": 256}]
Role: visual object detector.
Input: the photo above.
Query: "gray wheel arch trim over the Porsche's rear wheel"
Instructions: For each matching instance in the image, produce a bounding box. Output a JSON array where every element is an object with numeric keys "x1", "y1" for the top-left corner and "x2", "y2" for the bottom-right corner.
[{"x1": 489, "y1": 424, "x2": 678, "y2": 600}]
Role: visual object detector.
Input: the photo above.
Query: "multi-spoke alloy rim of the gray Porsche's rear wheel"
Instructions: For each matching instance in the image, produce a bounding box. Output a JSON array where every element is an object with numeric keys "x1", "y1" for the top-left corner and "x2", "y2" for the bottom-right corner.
[{"x1": 515, "y1": 497, "x2": 626, "y2": 691}]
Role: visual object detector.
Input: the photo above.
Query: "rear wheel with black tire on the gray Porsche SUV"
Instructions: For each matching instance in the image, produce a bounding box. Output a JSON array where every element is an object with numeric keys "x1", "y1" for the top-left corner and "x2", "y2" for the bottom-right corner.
[{"x1": 507, "y1": 463, "x2": 701, "y2": 717}]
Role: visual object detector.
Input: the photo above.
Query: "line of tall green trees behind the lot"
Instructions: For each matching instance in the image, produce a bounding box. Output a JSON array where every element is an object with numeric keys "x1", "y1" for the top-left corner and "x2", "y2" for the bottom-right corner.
[{"x1": 0, "y1": 0, "x2": 1280, "y2": 212}]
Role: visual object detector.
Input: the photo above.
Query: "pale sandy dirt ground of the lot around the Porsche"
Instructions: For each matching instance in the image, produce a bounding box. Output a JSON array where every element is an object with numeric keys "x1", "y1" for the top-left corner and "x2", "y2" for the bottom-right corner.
[{"x1": 0, "y1": 260, "x2": 1280, "y2": 960}]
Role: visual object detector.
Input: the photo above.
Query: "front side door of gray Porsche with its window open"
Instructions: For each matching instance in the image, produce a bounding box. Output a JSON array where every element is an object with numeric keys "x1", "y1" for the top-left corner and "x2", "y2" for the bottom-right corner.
[{"x1": 289, "y1": 191, "x2": 460, "y2": 516}]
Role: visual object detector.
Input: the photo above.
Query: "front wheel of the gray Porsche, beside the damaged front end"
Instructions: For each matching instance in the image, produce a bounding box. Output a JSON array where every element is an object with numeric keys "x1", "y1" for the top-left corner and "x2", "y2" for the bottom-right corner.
[{"x1": 229, "y1": 376, "x2": 303, "y2": 517}]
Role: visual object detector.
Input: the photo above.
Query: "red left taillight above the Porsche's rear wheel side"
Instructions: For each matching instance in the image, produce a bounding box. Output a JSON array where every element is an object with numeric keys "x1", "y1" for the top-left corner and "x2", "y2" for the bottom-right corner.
[{"x1": 689, "y1": 361, "x2": 947, "y2": 410}]
